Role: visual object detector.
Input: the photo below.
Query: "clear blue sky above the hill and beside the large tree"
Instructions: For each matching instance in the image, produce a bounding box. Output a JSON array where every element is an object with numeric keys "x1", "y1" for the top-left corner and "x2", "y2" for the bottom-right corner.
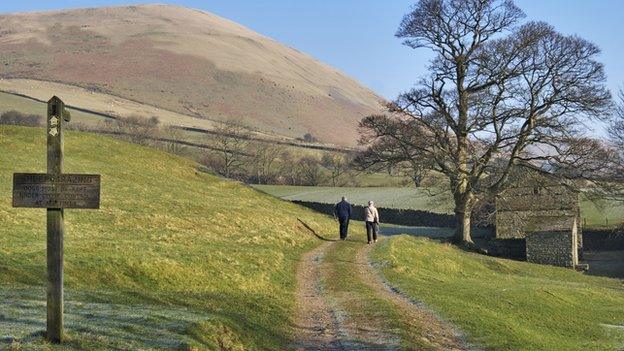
[{"x1": 0, "y1": 0, "x2": 624, "y2": 98}]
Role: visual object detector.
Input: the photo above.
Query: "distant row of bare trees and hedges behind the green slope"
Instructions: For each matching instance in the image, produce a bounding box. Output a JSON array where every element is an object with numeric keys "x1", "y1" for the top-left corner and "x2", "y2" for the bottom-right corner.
[{"x1": 0, "y1": 110, "x2": 368, "y2": 186}]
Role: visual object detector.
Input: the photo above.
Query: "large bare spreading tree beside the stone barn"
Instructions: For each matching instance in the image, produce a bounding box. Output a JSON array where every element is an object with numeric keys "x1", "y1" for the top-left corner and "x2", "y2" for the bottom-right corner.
[{"x1": 363, "y1": 0, "x2": 610, "y2": 245}]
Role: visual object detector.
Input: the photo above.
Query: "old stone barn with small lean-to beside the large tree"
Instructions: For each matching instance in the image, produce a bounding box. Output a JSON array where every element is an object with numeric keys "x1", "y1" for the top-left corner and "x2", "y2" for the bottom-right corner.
[{"x1": 496, "y1": 165, "x2": 583, "y2": 267}]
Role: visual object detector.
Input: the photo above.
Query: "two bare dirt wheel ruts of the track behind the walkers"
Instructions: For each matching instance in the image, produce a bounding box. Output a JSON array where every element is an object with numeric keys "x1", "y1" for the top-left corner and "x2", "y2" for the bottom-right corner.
[{"x1": 293, "y1": 241, "x2": 469, "y2": 350}]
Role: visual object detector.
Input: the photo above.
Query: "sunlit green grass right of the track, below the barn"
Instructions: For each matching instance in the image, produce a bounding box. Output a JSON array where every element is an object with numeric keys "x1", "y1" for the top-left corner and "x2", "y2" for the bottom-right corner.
[{"x1": 373, "y1": 236, "x2": 624, "y2": 351}]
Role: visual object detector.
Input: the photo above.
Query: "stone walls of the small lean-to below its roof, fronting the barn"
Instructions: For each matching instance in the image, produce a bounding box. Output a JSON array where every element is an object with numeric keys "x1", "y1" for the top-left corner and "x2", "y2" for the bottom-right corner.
[{"x1": 525, "y1": 231, "x2": 578, "y2": 267}]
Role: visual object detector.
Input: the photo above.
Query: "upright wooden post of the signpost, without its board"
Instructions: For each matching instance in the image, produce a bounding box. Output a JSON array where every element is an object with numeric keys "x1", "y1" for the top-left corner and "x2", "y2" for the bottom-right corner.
[{"x1": 46, "y1": 96, "x2": 69, "y2": 343}]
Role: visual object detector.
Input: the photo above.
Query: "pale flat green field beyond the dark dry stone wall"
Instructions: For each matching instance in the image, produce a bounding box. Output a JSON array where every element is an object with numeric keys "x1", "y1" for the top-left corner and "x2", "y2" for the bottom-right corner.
[{"x1": 254, "y1": 185, "x2": 624, "y2": 228}]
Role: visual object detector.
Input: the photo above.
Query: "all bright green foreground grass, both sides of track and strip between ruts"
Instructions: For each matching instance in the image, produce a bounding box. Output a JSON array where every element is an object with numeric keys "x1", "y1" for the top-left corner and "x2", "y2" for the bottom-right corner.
[{"x1": 0, "y1": 126, "x2": 624, "y2": 351}]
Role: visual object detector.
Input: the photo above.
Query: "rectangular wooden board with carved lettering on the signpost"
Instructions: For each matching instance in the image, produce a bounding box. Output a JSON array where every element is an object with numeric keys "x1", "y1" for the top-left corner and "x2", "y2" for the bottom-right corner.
[{"x1": 13, "y1": 173, "x2": 100, "y2": 209}]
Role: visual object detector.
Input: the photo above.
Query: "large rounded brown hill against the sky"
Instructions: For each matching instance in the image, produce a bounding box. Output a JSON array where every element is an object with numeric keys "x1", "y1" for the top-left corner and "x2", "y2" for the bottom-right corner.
[{"x1": 0, "y1": 5, "x2": 381, "y2": 145}]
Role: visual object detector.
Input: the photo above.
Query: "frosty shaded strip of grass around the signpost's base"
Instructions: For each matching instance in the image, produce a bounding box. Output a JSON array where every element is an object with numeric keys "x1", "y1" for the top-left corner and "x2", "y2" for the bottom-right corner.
[{"x1": 0, "y1": 287, "x2": 289, "y2": 350}]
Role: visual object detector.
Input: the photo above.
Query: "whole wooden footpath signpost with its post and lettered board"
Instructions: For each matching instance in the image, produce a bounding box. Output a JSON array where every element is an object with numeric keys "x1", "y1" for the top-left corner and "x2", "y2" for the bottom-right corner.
[{"x1": 13, "y1": 96, "x2": 100, "y2": 343}]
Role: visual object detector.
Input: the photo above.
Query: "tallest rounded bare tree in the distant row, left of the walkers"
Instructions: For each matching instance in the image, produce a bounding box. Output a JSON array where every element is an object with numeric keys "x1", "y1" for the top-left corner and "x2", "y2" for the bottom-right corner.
[{"x1": 212, "y1": 120, "x2": 249, "y2": 178}]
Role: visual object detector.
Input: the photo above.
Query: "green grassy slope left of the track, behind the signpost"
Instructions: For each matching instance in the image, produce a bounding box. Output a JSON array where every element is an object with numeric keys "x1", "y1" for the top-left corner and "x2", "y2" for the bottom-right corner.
[{"x1": 0, "y1": 126, "x2": 333, "y2": 350}]
